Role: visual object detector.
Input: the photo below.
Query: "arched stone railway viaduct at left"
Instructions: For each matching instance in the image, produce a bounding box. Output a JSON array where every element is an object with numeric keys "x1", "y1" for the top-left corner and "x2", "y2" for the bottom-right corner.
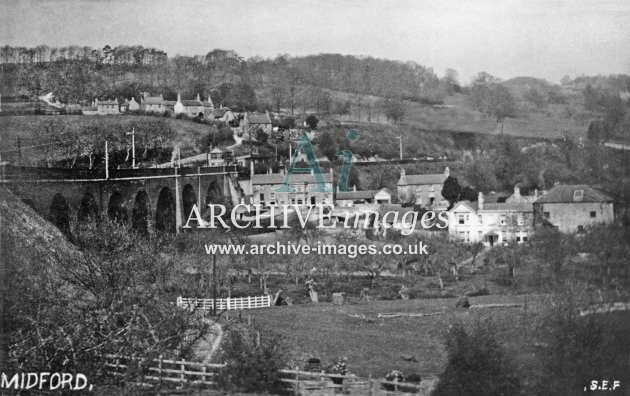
[{"x1": 0, "y1": 166, "x2": 243, "y2": 232}]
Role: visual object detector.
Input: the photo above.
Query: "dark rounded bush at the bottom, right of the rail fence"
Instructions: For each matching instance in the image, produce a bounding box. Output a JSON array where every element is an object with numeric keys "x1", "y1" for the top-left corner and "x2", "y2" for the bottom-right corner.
[{"x1": 432, "y1": 322, "x2": 520, "y2": 396}]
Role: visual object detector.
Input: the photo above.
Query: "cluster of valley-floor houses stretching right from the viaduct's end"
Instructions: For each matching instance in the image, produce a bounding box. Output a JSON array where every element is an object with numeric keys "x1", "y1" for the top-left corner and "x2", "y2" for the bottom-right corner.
[{"x1": 246, "y1": 168, "x2": 614, "y2": 246}]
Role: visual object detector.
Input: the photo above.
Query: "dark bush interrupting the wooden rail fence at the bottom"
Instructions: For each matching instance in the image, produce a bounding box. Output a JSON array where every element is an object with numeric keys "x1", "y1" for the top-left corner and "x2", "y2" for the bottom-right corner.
[{"x1": 217, "y1": 323, "x2": 289, "y2": 394}]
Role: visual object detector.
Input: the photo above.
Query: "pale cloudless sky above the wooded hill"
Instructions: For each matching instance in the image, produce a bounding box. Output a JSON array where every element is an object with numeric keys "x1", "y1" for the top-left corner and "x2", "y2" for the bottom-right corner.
[{"x1": 0, "y1": 0, "x2": 630, "y2": 83}]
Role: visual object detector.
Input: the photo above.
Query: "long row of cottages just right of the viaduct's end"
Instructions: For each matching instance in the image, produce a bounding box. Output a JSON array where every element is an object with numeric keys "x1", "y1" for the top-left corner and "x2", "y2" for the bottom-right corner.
[{"x1": 252, "y1": 169, "x2": 334, "y2": 206}]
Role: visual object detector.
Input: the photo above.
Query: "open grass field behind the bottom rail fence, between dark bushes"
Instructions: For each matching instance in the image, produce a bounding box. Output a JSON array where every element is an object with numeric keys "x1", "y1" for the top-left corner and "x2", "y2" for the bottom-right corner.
[{"x1": 243, "y1": 296, "x2": 544, "y2": 377}]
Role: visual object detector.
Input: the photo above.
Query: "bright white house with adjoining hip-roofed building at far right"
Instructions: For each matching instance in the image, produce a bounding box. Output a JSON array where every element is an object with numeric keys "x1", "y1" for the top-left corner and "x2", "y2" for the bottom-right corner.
[{"x1": 448, "y1": 185, "x2": 614, "y2": 246}]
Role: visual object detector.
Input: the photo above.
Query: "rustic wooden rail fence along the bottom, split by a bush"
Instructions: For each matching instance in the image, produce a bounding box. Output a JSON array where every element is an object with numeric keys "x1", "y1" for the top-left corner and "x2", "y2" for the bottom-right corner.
[{"x1": 105, "y1": 355, "x2": 437, "y2": 396}]
